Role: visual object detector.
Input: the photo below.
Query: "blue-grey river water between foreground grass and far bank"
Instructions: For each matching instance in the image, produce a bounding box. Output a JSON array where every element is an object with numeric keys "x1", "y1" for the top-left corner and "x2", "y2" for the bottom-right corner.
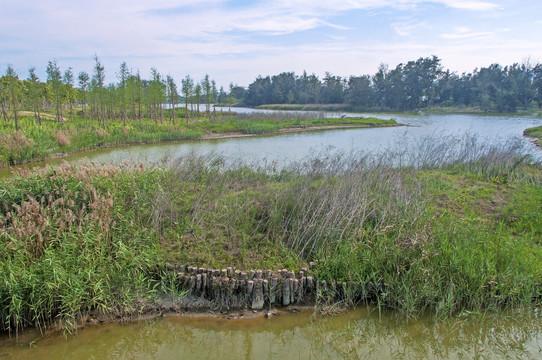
[{"x1": 0, "y1": 112, "x2": 542, "y2": 177}]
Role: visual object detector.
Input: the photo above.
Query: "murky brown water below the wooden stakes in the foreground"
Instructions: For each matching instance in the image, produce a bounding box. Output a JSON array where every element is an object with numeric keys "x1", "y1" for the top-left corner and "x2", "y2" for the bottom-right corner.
[{"x1": 0, "y1": 307, "x2": 542, "y2": 360}]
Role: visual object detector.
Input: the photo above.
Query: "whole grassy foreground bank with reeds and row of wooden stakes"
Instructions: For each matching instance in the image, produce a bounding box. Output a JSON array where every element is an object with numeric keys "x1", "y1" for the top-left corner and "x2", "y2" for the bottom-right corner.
[{"x1": 0, "y1": 138, "x2": 542, "y2": 330}]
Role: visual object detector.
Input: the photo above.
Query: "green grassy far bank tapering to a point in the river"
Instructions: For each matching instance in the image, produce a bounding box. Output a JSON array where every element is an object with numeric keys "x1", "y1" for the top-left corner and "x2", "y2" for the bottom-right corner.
[{"x1": 0, "y1": 113, "x2": 400, "y2": 167}]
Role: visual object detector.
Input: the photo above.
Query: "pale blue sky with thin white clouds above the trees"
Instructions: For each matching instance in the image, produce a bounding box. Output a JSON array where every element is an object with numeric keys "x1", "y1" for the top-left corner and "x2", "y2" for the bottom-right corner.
[{"x1": 0, "y1": 0, "x2": 542, "y2": 88}]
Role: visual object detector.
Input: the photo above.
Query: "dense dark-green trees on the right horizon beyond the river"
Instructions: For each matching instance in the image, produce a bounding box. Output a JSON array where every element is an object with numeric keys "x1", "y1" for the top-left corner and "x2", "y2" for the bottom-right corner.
[{"x1": 244, "y1": 56, "x2": 542, "y2": 112}]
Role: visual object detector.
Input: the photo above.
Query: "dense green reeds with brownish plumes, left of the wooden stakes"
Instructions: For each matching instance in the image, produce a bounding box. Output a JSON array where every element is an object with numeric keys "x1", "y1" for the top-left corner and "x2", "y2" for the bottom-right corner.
[{"x1": 0, "y1": 164, "x2": 167, "y2": 330}]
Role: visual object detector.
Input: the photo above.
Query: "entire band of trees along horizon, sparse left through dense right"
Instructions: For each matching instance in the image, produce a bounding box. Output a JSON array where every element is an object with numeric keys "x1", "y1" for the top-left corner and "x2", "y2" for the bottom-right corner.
[{"x1": 0, "y1": 56, "x2": 542, "y2": 134}]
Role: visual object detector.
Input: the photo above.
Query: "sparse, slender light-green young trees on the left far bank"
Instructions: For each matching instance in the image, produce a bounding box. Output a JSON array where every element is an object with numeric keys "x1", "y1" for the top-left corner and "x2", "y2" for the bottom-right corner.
[{"x1": 0, "y1": 56, "x2": 239, "y2": 130}]
